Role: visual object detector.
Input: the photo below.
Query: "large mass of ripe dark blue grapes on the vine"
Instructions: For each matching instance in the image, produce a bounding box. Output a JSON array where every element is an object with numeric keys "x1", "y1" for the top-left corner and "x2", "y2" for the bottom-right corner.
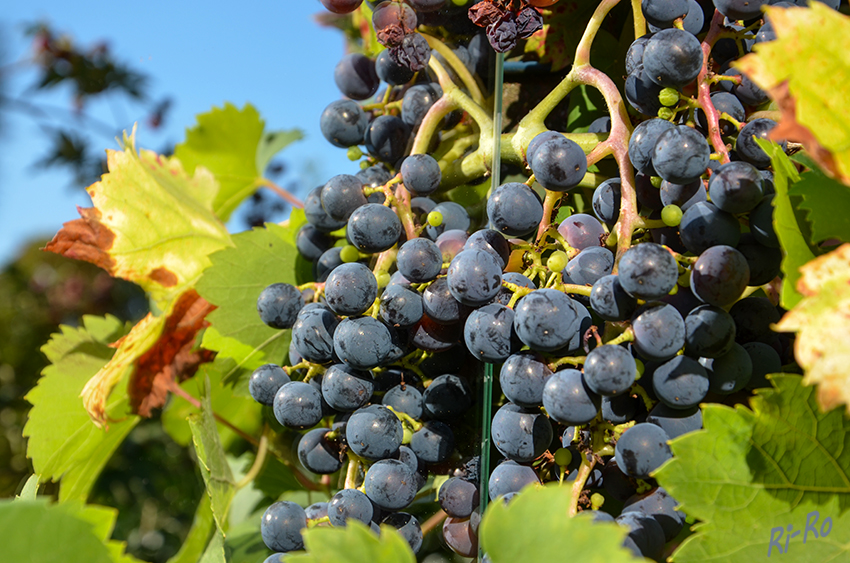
[{"x1": 250, "y1": 0, "x2": 808, "y2": 559}]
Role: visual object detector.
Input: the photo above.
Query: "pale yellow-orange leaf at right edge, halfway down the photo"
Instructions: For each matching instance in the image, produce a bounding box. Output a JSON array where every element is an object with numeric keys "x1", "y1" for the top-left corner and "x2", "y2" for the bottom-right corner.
[{"x1": 776, "y1": 244, "x2": 850, "y2": 413}]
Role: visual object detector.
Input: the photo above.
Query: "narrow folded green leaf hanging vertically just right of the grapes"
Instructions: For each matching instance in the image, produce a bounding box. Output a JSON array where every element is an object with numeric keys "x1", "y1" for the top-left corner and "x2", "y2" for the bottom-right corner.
[{"x1": 756, "y1": 139, "x2": 815, "y2": 309}]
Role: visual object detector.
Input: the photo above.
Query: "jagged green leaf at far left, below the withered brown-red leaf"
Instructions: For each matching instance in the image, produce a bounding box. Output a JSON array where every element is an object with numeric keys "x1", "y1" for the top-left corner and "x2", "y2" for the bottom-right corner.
[{"x1": 23, "y1": 316, "x2": 139, "y2": 501}]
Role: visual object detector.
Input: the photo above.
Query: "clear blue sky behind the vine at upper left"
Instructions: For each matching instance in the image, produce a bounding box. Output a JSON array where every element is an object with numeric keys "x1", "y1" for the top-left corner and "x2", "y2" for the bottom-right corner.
[{"x1": 0, "y1": 0, "x2": 356, "y2": 264}]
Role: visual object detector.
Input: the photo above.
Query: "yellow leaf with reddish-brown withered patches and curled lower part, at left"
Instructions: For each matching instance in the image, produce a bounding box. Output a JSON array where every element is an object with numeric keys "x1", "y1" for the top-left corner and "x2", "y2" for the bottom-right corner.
[{"x1": 46, "y1": 135, "x2": 232, "y2": 423}]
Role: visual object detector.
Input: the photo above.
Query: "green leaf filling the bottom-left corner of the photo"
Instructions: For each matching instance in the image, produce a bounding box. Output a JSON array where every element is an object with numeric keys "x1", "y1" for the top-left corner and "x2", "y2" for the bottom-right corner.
[{"x1": 0, "y1": 499, "x2": 140, "y2": 563}]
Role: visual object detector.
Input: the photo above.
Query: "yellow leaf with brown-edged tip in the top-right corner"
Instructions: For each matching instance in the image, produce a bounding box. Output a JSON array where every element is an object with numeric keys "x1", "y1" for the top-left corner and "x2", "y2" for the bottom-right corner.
[{"x1": 734, "y1": 2, "x2": 850, "y2": 185}]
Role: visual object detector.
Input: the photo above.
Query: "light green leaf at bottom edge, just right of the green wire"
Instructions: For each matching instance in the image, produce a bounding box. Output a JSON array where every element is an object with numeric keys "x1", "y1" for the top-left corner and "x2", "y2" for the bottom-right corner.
[{"x1": 480, "y1": 485, "x2": 641, "y2": 563}]
